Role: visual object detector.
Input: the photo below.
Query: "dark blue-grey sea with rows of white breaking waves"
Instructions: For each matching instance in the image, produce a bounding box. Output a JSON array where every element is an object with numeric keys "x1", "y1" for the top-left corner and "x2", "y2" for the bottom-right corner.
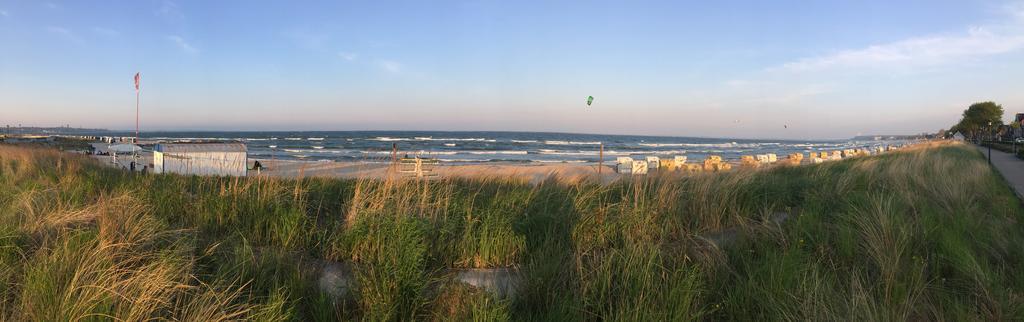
[{"x1": 97, "y1": 131, "x2": 908, "y2": 163}]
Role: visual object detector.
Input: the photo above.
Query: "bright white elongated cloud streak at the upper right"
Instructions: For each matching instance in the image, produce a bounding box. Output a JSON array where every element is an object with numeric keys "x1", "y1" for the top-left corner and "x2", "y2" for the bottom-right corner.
[{"x1": 773, "y1": 27, "x2": 1024, "y2": 72}]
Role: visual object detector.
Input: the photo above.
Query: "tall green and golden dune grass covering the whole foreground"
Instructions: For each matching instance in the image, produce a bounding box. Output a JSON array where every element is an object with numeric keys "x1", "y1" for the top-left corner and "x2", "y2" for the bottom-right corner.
[{"x1": 0, "y1": 144, "x2": 1024, "y2": 321}]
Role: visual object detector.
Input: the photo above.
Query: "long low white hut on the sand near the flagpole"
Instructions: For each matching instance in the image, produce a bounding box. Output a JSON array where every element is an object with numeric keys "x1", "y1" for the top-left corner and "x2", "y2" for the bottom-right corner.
[{"x1": 153, "y1": 144, "x2": 248, "y2": 176}]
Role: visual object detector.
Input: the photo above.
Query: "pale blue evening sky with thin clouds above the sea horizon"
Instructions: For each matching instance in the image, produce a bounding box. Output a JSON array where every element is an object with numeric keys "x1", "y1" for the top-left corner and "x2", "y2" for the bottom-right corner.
[{"x1": 0, "y1": 0, "x2": 1024, "y2": 138}]
